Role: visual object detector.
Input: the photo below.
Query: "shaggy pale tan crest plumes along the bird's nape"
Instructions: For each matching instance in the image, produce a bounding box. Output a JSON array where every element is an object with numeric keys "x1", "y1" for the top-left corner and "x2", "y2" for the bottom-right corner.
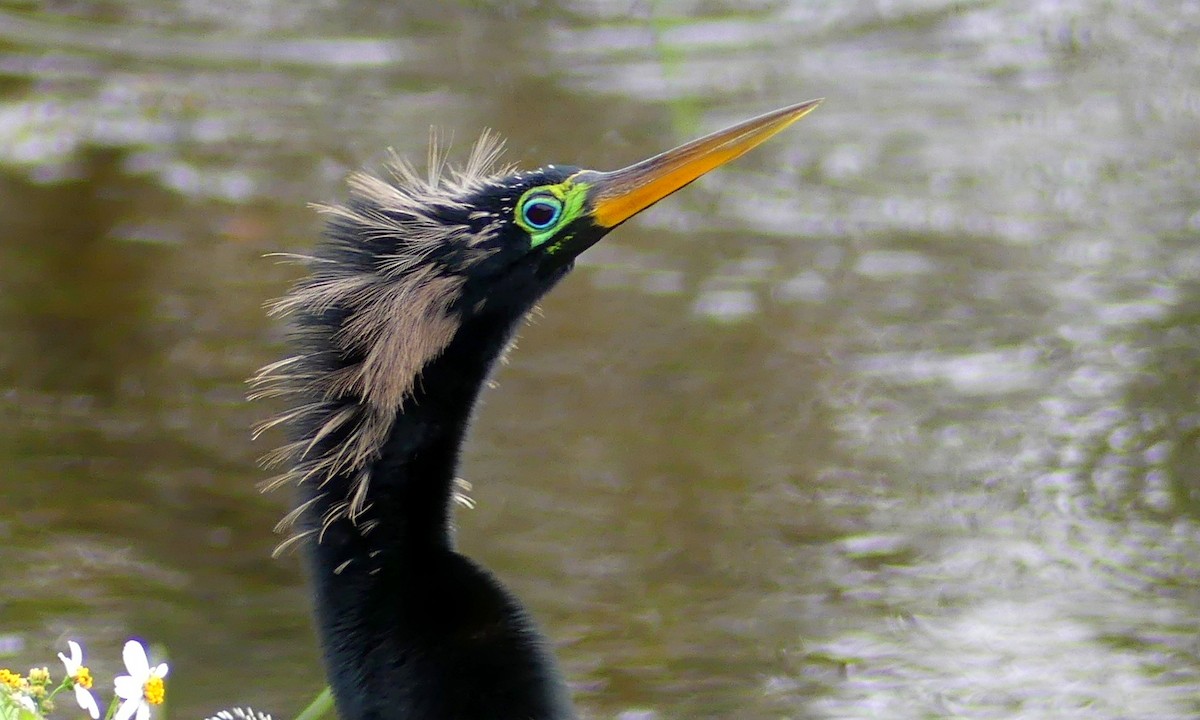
[{"x1": 251, "y1": 132, "x2": 512, "y2": 554}]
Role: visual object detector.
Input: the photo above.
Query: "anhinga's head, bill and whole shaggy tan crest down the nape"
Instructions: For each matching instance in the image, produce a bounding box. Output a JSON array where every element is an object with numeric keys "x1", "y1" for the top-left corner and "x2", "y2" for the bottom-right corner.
[{"x1": 254, "y1": 101, "x2": 820, "y2": 535}]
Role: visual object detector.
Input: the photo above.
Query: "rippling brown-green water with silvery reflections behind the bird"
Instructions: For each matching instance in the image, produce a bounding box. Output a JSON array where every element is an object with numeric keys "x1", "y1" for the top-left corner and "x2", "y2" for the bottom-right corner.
[{"x1": 0, "y1": 0, "x2": 1200, "y2": 719}]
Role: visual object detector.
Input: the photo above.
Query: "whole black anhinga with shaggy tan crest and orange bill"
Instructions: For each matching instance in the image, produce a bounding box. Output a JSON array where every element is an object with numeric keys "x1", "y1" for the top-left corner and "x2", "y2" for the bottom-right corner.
[{"x1": 244, "y1": 101, "x2": 820, "y2": 720}]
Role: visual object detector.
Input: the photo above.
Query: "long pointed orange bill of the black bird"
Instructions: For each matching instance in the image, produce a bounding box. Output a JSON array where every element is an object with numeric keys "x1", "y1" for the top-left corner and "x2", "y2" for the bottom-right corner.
[{"x1": 577, "y1": 100, "x2": 821, "y2": 228}]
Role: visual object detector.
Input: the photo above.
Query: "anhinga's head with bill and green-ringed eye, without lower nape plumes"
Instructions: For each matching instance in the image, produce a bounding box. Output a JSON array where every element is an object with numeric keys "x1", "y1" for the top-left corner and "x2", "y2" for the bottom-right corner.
[{"x1": 316, "y1": 101, "x2": 820, "y2": 336}]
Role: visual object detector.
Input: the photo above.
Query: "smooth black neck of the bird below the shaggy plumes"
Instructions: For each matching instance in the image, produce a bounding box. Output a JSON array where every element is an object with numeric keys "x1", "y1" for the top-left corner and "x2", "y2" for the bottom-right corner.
[{"x1": 302, "y1": 312, "x2": 574, "y2": 720}]
